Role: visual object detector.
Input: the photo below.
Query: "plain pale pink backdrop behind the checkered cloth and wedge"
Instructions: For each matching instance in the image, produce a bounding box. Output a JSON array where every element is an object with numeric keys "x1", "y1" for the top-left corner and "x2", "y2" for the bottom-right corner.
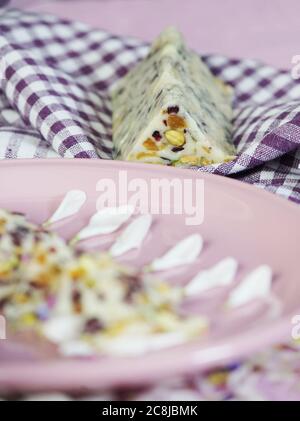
[{"x1": 11, "y1": 0, "x2": 300, "y2": 68}]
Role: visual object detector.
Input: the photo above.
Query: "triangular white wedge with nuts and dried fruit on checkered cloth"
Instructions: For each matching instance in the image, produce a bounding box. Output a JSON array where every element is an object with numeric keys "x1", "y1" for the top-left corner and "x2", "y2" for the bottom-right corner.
[{"x1": 112, "y1": 28, "x2": 235, "y2": 166}]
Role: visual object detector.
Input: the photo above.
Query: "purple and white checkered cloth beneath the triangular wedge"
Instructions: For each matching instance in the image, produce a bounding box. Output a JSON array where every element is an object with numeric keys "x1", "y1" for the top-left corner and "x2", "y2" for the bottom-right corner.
[{"x1": 0, "y1": 10, "x2": 300, "y2": 202}]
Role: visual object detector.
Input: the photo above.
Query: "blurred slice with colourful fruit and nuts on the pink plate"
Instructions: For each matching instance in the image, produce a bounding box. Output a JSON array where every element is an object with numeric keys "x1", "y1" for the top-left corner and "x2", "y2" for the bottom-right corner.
[{"x1": 0, "y1": 209, "x2": 209, "y2": 356}]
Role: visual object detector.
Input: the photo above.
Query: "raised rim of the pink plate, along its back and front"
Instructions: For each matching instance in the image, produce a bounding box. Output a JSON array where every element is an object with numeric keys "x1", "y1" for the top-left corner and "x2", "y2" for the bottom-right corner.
[{"x1": 0, "y1": 158, "x2": 300, "y2": 391}]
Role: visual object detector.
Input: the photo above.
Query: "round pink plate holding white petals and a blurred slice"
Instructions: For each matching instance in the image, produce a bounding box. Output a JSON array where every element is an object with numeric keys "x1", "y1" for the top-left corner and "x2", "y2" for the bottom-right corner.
[{"x1": 0, "y1": 159, "x2": 300, "y2": 391}]
